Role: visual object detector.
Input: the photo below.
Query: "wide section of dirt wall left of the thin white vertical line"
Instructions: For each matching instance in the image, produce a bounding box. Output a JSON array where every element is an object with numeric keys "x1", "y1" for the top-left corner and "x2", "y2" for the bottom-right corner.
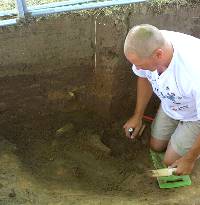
[{"x1": 0, "y1": 14, "x2": 94, "y2": 137}]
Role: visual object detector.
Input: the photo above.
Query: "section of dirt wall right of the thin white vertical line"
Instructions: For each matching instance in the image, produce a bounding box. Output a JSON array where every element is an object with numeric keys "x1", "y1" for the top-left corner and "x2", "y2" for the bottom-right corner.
[{"x1": 96, "y1": 4, "x2": 200, "y2": 119}]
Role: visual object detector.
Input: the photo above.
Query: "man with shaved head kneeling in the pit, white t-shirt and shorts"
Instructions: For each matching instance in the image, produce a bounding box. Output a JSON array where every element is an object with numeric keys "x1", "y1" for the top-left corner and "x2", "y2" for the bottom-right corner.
[{"x1": 124, "y1": 24, "x2": 200, "y2": 175}]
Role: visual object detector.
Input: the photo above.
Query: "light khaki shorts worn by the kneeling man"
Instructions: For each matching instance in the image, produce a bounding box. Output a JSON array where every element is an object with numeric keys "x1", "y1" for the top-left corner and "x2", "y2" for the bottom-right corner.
[{"x1": 151, "y1": 106, "x2": 200, "y2": 156}]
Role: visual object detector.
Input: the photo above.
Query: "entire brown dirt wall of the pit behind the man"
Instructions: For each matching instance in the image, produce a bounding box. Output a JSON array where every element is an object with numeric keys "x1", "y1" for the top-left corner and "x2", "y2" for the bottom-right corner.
[{"x1": 0, "y1": 4, "x2": 200, "y2": 125}]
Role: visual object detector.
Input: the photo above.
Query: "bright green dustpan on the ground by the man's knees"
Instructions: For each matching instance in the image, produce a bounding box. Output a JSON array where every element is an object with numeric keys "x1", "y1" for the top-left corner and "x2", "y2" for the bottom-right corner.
[{"x1": 150, "y1": 150, "x2": 192, "y2": 189}]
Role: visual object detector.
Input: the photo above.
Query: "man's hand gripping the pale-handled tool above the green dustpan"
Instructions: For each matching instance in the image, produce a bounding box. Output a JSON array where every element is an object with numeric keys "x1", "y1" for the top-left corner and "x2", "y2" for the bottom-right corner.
[{"x1": 170, "y1": 156, "x2": 195, "y2": 175}]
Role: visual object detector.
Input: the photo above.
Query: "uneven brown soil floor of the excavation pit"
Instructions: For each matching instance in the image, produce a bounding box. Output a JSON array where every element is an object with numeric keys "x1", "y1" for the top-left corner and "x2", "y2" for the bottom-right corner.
[{"x1": 0, "y1": 113, "x2": 200, "y2": 205}]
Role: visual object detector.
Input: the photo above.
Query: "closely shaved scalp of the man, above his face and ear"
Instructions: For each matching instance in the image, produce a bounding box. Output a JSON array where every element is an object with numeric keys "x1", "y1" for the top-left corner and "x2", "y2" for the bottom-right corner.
[{"x1": 124, "y1": 24, "x2": 166, "y2": 58}]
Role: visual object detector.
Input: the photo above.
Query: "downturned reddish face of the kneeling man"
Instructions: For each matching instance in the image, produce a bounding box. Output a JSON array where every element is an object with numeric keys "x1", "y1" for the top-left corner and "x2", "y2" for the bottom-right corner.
[{"x1": 125, "y1": 53, "x2": 158, "y2": 71}]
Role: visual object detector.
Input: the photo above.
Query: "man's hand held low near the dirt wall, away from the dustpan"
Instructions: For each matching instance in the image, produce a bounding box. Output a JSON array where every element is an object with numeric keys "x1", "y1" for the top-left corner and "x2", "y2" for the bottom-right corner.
[{"x1": 123, "y1": 115, "x2": 142, "y2": 139}]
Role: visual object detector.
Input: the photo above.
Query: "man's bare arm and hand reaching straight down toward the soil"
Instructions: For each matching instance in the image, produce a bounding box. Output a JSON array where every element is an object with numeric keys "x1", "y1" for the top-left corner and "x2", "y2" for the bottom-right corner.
[{"x1": 123, "y1": 77, "x2": 153, "y2": 138}]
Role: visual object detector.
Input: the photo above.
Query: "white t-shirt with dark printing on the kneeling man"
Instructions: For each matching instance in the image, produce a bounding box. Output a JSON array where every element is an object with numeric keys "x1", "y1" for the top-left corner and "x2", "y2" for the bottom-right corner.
[{"x1": 132, "y1": 30, "x2": 200, "y2": 121}]
